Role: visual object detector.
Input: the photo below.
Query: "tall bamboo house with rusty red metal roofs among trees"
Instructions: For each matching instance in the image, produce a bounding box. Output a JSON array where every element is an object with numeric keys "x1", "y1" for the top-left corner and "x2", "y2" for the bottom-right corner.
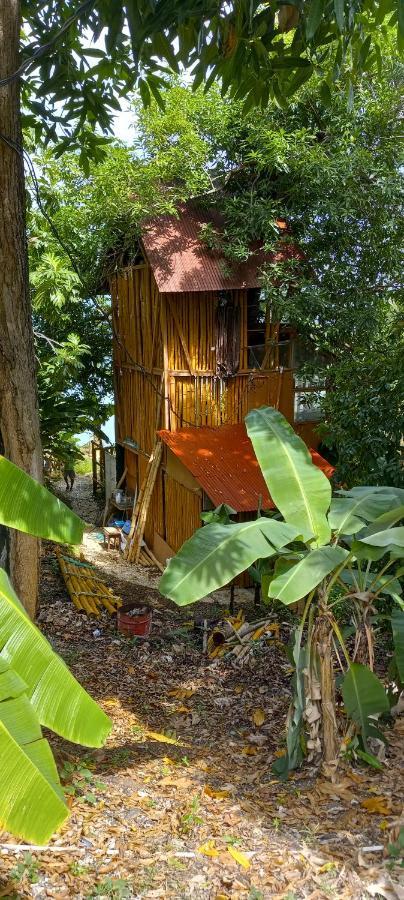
[{"x1": 111, "y1": 203, "x2": 331, "y2": 562}]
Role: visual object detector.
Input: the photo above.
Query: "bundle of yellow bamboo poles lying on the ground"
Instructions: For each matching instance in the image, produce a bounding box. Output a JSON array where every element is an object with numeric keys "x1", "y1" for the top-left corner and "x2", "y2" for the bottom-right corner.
[{"x1": 56, "y1": 549, "x2": 122, "y2": 618}]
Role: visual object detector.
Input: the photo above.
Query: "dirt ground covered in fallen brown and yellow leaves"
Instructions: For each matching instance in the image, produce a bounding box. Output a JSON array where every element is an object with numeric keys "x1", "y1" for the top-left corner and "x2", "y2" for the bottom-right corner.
[{"x1": 0, "y1": 477, "x2": 404, "y2": 900}]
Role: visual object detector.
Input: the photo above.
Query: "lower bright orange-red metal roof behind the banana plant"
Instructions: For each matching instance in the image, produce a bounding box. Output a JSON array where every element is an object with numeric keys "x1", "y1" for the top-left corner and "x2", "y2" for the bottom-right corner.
[{"x1": 158, "y1": 423, "x2": 334, "y2": 512}]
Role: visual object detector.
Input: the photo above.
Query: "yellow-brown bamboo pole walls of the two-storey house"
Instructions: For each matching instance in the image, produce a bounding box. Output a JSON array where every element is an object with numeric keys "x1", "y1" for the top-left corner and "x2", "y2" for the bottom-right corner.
[{"x1": 111, "y1": 263, "x2": 318, "y2": 550}]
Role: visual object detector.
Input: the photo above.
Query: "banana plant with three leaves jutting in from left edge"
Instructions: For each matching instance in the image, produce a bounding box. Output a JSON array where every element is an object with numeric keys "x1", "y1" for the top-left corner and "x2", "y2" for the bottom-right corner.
[{"x1": 0, "y1": 457, "x2": 111, "y2": 844}]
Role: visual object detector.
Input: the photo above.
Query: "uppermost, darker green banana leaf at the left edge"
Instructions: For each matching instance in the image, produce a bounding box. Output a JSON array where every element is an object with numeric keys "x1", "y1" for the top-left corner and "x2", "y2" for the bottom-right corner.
[{"x1": 0, "y1": 456, "x2": 85, "y2": 544}]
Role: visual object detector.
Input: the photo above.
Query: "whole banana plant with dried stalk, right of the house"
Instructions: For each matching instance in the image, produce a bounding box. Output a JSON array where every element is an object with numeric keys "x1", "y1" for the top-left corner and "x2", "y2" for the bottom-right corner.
[{"x1": 160, "y1": 407, "x2": 404, "y2": 774}]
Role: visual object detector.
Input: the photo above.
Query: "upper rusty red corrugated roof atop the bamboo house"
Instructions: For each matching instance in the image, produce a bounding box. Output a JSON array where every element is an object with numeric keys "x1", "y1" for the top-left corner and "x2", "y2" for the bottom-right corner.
[{"x1": 142, "y1": 202, "x2": 301, "y2": 293}]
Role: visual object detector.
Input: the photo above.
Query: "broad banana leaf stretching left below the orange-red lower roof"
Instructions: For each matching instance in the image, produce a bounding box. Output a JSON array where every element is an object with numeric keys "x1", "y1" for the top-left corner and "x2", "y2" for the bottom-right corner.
[{"x1": 159, "y1": 517, "x2": 299, "y2": 606}]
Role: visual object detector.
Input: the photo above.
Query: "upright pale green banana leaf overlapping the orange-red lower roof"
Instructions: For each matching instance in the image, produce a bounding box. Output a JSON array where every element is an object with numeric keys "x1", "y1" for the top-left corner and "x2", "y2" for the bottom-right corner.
[{"x1": 245, "y1": 406, "x2": 331, "y2": 547}]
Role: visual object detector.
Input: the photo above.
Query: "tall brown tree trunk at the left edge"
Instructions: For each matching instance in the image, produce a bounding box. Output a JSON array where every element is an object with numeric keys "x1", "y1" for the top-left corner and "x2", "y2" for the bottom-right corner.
[{"x1": 0, "y1": 0, "x2": 42, "y2": 617}]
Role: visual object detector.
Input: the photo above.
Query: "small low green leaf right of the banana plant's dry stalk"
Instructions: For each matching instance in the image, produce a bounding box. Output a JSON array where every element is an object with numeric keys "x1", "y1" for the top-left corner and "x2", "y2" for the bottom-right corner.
[{"x1": 341, "y1": 663, "x2": 389, "y2": 752}]
